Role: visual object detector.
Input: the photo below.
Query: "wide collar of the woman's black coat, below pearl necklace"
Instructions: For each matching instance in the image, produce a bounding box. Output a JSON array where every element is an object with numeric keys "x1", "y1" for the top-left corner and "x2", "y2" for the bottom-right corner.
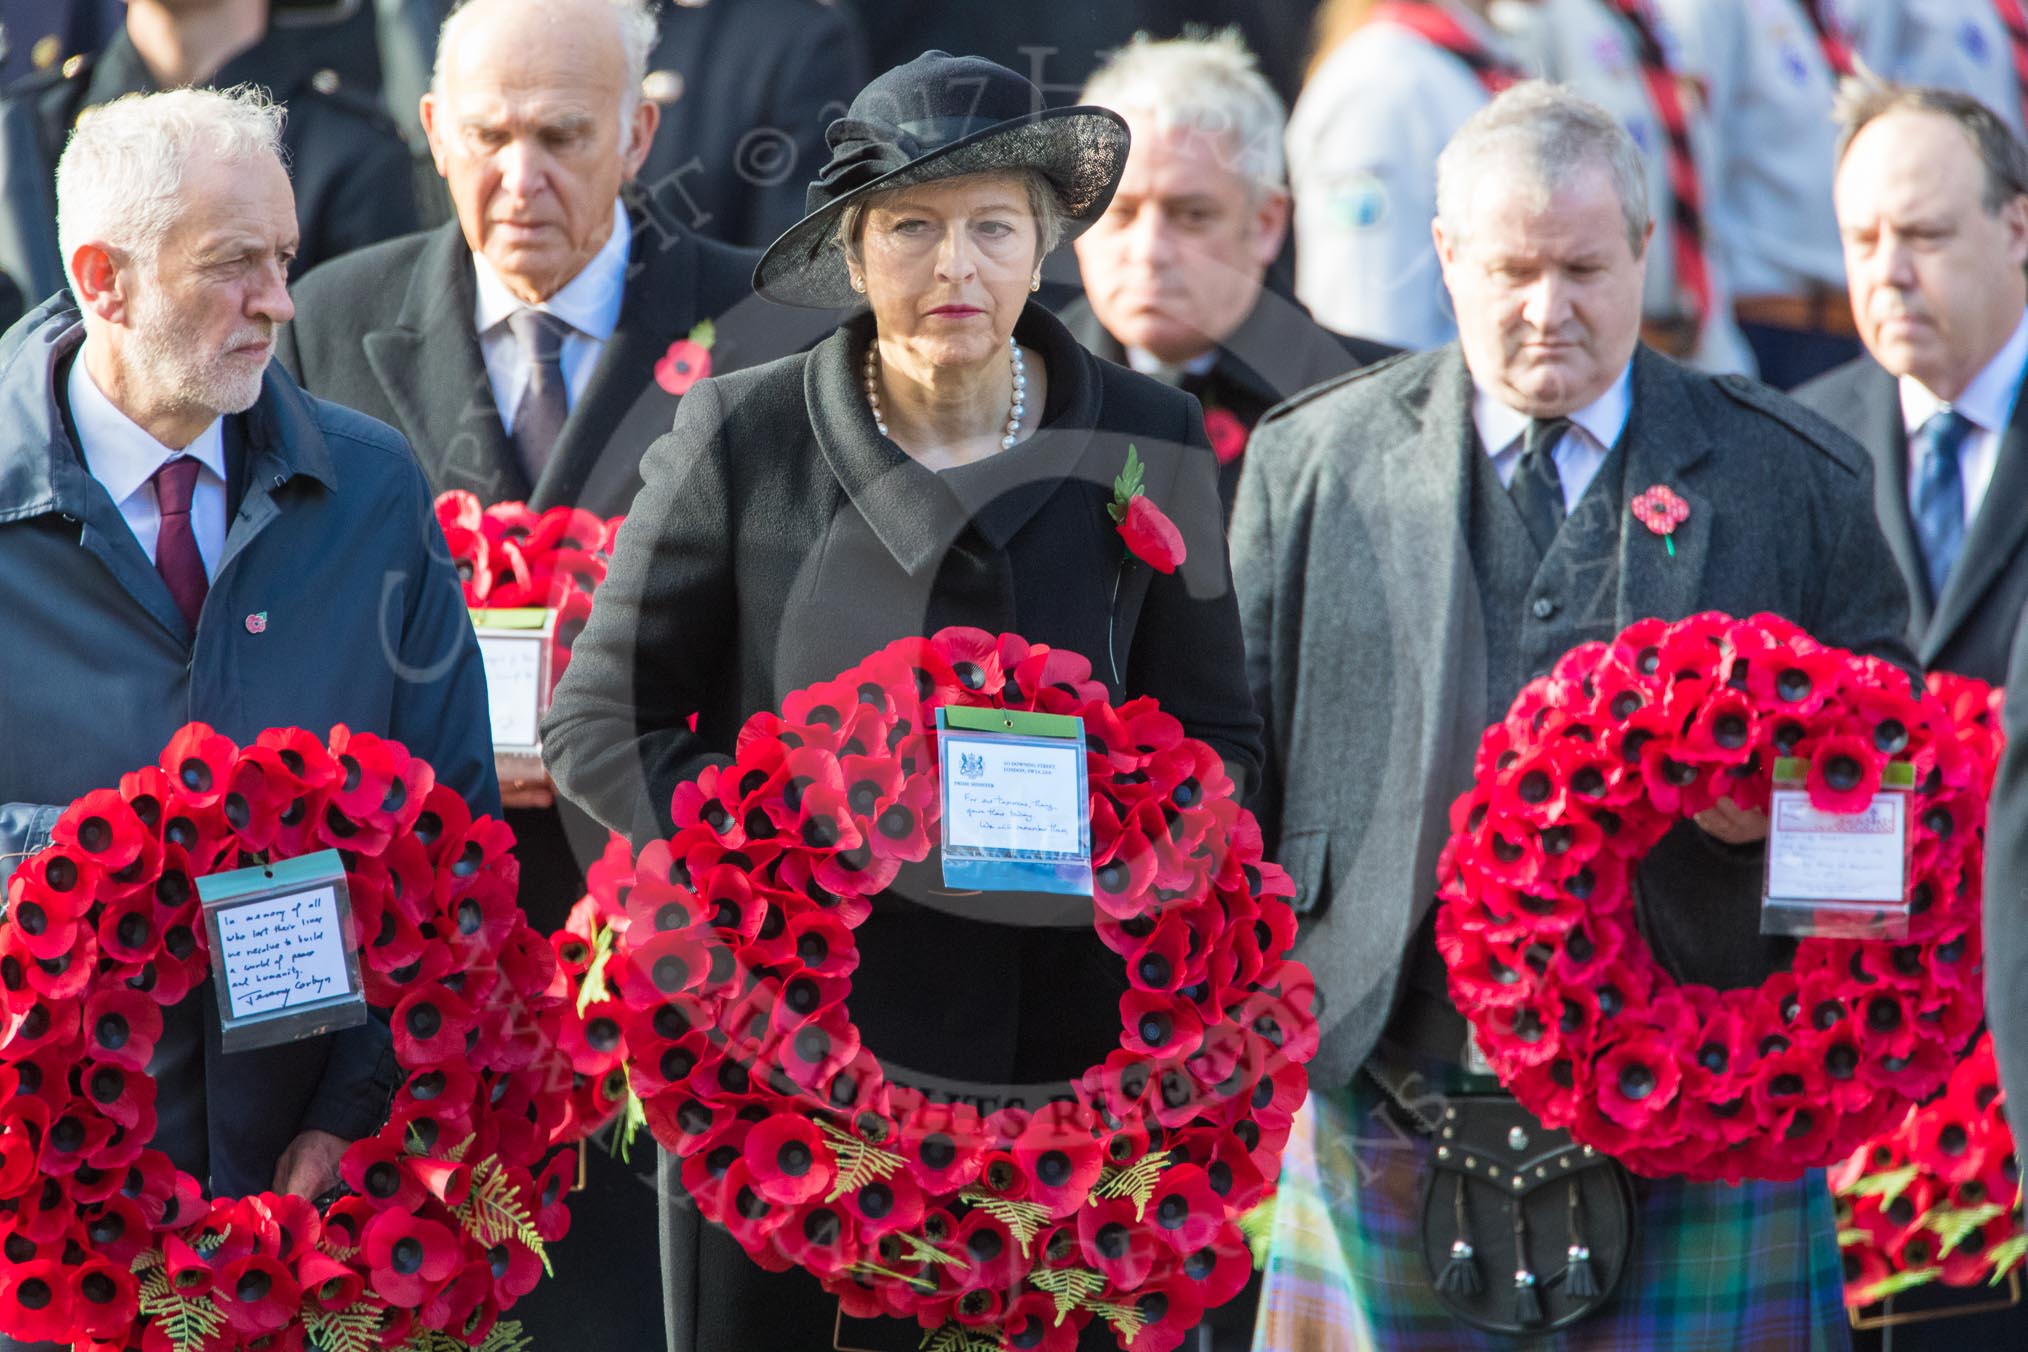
[{"x1": 803, "y1": 304, "x2": 1117, "y2": 576}]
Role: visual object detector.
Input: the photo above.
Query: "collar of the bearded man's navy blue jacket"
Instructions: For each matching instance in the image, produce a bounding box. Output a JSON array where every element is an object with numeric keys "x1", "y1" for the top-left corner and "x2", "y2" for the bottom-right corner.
[{"x1": 0, "y1": 292, "x2": 339, "y2": 521}]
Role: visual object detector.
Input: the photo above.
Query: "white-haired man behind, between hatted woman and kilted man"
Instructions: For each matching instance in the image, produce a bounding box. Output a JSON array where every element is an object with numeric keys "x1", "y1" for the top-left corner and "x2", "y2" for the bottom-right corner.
[{"x1": 1061, "y1": 28, "x2": 1393, "y2": 515}]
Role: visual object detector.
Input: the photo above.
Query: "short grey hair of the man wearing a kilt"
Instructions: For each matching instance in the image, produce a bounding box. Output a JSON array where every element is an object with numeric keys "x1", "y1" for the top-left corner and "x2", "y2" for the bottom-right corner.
[{"x1": 1436, "y1": 79, "x2": 1649, "y2": 257}]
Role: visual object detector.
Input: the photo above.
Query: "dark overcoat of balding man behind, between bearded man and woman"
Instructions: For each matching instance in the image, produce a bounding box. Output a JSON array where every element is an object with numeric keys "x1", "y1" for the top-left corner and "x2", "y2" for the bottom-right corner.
[{"x1": 276, "y1": 195, "x2": 831, "y2": 517}]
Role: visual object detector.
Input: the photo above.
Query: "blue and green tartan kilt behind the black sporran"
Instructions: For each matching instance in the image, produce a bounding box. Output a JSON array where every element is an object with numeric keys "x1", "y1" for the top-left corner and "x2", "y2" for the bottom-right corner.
[{"x1": 1253, "y1": 1074, "x2": 1852, "y2": 1352}]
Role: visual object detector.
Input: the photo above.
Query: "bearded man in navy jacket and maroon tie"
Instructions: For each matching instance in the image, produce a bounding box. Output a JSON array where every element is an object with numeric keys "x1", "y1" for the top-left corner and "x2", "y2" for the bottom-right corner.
[{"x1": 0, "y1": 89, "x2": 499, "y2": 1352}]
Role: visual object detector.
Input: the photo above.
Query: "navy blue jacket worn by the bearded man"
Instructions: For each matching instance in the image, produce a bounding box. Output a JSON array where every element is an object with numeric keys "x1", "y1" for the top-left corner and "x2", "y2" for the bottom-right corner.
[{"x1": 0, "y1": 294, "x2": 499, "y2": 1196}]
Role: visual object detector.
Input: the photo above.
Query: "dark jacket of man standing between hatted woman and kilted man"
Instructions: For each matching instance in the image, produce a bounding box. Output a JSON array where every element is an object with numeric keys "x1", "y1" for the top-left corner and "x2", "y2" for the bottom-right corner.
[{"x1": 1057, "y1": 288, "x2": 1397, "y2": 517}]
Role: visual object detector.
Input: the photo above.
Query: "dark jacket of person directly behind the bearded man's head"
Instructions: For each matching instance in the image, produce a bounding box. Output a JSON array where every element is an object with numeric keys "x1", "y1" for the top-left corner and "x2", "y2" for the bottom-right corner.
[{"x1": 0, "y1": 28, "x2": 420, "y2": 291}]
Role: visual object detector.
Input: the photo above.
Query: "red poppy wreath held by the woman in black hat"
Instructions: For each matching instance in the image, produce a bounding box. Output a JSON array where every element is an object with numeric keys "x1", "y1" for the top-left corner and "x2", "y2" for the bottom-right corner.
[{"x1": 566, "y1": 628, "x2": 1316, "y2": 1352}]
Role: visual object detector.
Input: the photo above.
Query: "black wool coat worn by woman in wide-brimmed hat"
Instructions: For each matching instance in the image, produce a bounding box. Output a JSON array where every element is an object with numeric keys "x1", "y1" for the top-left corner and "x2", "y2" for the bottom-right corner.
[{"x1": 544, "y1": 304, "x2": 1259, "y2": 1352}]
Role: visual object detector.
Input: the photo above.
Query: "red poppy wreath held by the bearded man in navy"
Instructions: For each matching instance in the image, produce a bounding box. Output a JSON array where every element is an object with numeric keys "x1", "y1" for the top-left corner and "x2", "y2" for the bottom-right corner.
[{"x1": 0, "y1": 724, "x2": 600, "y2": 1352}]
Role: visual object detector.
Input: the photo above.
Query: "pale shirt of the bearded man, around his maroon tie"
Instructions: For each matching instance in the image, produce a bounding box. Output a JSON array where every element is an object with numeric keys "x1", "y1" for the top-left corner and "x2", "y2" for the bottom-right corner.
[{"x1": 65, "y1": 353, "x2": 225, "y2": 578}]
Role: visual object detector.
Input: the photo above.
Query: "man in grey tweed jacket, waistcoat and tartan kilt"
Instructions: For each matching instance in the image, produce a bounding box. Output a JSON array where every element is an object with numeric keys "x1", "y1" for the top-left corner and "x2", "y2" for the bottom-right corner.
[{"x1": 1231, "y1": 81, "x2": 1912, "y2": 1352}]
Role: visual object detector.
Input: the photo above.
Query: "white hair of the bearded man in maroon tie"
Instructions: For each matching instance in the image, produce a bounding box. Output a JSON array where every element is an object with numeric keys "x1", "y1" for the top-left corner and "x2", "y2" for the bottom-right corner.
[{"x1": 57, "y1": 85, "x2": 284, "y2": 286}]
